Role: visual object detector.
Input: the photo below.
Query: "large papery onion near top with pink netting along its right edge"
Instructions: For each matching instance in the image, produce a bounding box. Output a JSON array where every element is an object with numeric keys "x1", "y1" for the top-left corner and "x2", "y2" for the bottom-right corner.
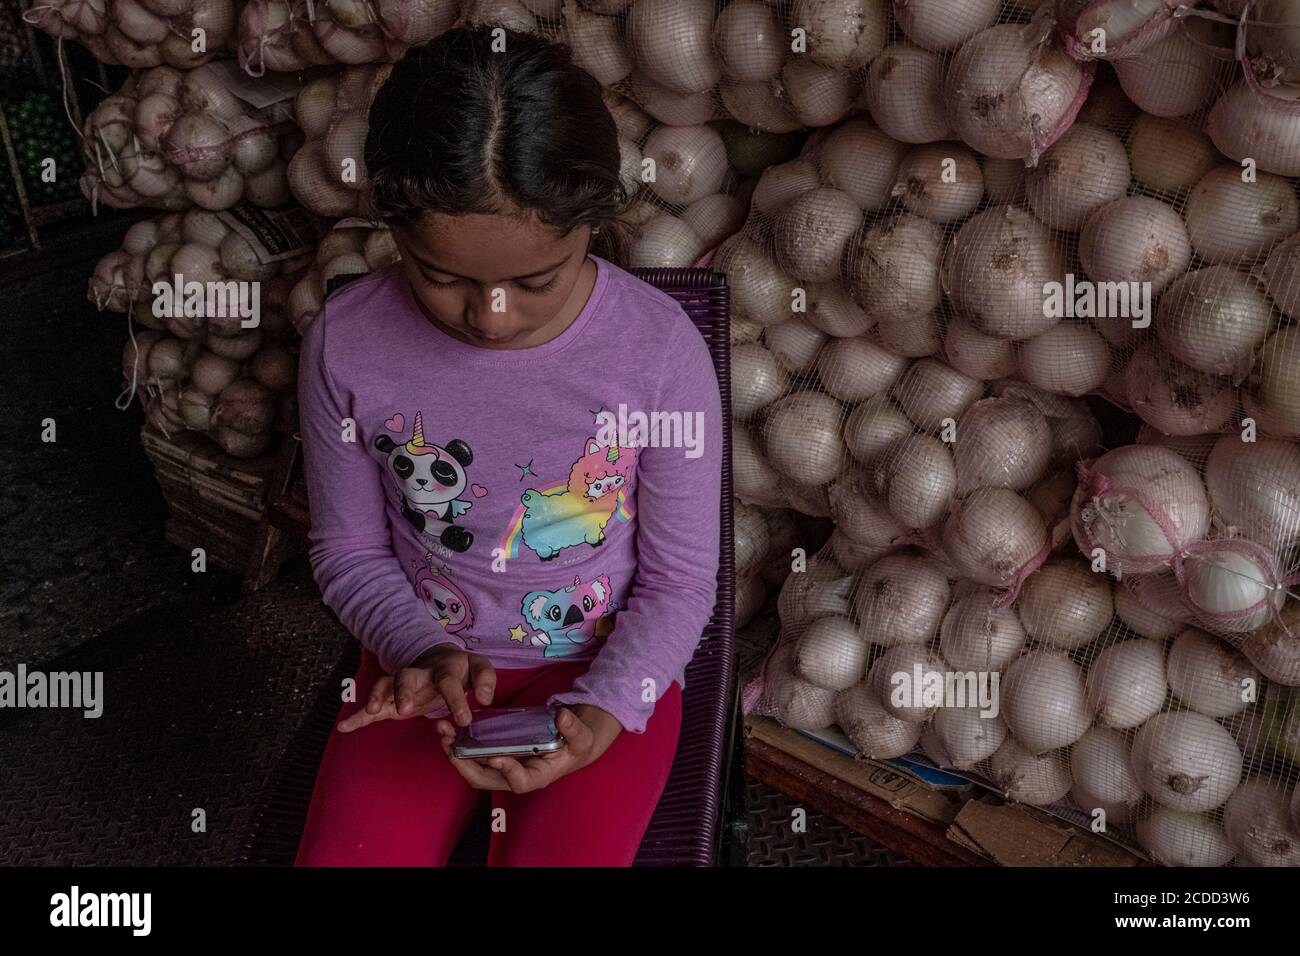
[{"x1": 944, "y1": 18, "x2": 1084, "y2": 163}]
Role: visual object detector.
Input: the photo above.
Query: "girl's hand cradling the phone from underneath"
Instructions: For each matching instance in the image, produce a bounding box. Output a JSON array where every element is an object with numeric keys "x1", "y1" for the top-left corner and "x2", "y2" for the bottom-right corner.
[{"x1": 436, "y1": 704, "x2": 623, "y2": 793}]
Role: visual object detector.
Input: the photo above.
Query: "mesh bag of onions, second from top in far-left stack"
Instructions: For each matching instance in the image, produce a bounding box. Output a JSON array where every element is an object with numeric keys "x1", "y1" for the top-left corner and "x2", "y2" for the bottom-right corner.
[{"x1": 81, "y1": 60, "x2": 302, "y2": 209}]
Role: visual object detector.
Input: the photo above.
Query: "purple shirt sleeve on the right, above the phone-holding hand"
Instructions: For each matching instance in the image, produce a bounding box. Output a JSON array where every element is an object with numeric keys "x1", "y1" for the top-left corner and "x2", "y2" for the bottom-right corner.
[{"x1": 547, "y1": 317, "x2": 723, "y2": 734}]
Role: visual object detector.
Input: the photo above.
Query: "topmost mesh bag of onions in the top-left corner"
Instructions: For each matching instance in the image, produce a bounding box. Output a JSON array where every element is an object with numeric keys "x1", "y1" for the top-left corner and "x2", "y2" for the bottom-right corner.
[{"x1": 23, "y1": 0, "x2": 237, "y2": 70}]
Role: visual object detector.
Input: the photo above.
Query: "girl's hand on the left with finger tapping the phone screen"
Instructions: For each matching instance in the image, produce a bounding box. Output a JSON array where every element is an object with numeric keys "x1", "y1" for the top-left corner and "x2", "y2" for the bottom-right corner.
[{"x1": 338, "y1": 644, "x2": 497, "y2": 734}]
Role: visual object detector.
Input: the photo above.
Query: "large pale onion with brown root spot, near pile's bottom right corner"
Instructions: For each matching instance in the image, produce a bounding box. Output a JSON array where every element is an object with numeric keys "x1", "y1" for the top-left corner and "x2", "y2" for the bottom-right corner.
[{"x1": 1131, "y1": 711, "x2": 1242, "y2": 813}]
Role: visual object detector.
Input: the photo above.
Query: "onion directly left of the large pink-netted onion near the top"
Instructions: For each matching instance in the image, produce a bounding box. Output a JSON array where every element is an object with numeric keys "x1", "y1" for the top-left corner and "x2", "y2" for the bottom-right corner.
[{"x1": 863, "y1": 43, "x2": 953, "y2": 143}]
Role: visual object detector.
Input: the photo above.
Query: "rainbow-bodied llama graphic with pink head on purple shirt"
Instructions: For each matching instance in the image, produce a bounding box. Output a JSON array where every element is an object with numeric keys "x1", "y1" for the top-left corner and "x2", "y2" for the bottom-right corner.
[{"x1": 501, "y1": 438, "x2": 636, "y2": 561}]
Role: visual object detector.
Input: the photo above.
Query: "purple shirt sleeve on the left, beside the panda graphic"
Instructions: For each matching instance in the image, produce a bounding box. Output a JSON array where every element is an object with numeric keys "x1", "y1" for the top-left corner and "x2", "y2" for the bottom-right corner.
[{"x1": 298, "y1": 303, "x2": 465, "y2": 674}]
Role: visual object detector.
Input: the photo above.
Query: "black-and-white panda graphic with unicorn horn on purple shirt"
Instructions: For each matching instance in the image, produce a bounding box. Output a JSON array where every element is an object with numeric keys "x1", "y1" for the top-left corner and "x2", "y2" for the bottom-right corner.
[{"x1": 374, "y1": 412, "x2": 475, "y2": 551}]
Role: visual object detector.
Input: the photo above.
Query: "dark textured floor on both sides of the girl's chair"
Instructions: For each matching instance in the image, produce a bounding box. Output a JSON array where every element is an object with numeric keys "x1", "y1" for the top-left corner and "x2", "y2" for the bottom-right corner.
[{"x1": 0, "y1": 219, "x2": 905, "y2": 866}]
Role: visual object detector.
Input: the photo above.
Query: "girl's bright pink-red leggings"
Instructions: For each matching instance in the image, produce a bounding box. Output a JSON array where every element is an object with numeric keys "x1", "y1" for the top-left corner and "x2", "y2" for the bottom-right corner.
[{"x1": 295, "y1": 650, "x2": 681, "y2": 866}]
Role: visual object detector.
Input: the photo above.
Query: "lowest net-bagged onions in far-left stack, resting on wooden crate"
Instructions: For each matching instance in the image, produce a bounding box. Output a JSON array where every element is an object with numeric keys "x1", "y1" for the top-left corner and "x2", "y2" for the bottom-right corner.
[{"x1": 87, "y1": 209, "x2": 315, "y2": 458}]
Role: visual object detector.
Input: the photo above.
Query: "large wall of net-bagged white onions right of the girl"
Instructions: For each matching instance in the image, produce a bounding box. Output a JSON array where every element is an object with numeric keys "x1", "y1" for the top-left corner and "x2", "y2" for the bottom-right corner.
[{"x1": 728, "y1": 0, "x2": 1300, "y2": 865}]
